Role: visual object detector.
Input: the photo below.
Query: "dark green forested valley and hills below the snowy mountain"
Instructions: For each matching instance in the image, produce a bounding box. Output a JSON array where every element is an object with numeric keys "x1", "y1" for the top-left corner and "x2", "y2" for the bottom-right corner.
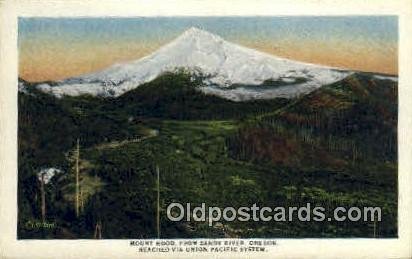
[{"x1": 18, "y1": 72, "x2": 398, "y2": 239}]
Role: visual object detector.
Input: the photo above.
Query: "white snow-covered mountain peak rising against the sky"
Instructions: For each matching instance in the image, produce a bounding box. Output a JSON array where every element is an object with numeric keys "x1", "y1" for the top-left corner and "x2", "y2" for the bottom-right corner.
[{"x1": 37, "y1": 28, "x2": 351, "y2": 101}]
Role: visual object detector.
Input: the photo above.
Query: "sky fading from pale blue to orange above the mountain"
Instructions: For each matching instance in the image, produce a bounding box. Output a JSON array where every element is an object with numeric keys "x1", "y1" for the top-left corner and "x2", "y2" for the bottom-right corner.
[{"x1": 18, "y1": 16, "x2": 398, "y2": 80}]
